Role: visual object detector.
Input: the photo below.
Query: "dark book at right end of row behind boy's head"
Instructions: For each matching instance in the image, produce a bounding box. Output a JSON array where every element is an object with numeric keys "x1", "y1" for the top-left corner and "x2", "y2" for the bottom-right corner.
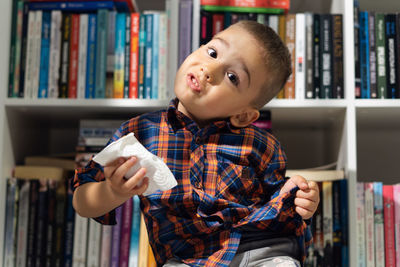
[{"x1": 332, "y1": 14, "x2": 344, "y2": 98}]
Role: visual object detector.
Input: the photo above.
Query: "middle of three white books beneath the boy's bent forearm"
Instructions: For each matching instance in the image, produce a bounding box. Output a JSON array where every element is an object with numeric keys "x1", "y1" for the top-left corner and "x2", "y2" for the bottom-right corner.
[{"x1": 86, "y1": 219, "x2": 102, "y2": 267}]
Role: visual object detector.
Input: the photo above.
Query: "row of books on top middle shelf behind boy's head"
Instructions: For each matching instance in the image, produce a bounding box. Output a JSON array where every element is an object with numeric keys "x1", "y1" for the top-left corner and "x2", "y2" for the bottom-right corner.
[{"x1": 200, "y1": 10, "x2": 344, "y2": 99}]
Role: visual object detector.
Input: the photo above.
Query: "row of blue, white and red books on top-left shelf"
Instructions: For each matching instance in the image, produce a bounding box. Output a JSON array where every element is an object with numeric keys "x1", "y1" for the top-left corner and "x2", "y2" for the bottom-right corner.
[{"x1": 9, "y1": 2, "x2": 172, "y2": 99}]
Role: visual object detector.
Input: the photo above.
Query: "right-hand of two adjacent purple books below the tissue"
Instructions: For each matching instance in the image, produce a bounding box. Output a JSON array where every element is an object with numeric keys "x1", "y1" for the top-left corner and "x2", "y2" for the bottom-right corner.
[{"x1": 119, "y1": 198, "x2": 133, "y2": 267}]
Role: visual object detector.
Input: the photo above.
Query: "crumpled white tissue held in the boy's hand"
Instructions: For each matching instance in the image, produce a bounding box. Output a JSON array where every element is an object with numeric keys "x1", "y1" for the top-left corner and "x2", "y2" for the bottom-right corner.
[{"x1": 93, "y1": 133, "x2": 178, "y2": 196}]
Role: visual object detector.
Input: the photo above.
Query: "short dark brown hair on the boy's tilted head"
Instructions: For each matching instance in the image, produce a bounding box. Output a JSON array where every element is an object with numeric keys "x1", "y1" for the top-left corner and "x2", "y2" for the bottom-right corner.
[{"x1": 234, "y1": 20, "x2": 292, "y2": 109}]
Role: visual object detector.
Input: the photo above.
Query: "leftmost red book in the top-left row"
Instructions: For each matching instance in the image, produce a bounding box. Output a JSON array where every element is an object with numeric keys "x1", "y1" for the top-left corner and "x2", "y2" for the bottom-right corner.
[{"x1": 68, "y1": 14, "x2": 79, "y2": 98}]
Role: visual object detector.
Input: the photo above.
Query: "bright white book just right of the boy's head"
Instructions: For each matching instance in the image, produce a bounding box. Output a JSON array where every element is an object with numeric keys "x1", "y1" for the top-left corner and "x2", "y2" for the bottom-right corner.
[{"x1": 295, "y1": 13, "x2": 306, "y2": 99}]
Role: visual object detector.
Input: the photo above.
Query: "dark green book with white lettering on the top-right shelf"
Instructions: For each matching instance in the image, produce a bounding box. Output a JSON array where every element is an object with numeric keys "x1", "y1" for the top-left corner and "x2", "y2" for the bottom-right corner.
[{"x1": 375, "y1": 13, "x2": 387, "y2": 98}]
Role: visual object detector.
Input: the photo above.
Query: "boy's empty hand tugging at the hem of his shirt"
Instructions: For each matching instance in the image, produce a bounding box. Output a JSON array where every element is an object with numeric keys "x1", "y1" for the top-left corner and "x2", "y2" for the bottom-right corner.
[{"x1": 280, "y1": 175, "x2": 319, "y2": 220}]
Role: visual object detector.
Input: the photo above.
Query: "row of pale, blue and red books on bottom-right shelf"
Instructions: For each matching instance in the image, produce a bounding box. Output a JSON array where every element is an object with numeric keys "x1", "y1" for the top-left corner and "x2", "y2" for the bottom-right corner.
[{"x1": 356, "y1": 182, "x2": 400, "y2": 266}]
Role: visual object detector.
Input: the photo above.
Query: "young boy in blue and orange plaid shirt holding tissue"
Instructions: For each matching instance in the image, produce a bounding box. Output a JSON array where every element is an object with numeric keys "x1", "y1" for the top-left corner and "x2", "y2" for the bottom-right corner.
[{"x1": 73, "y1": 21, "x2": 319, "y2": 266}]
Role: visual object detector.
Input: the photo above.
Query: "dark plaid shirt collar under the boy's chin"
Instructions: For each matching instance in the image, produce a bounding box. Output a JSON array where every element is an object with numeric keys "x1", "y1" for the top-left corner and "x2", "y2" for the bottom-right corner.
[{"x1": 167, "y1": 98, "x2": 240, "y2": 133}]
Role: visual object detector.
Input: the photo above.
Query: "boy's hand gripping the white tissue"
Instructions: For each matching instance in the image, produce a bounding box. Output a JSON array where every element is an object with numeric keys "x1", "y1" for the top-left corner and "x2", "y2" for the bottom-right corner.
[{"x1": 104, "y1": 157, "x2": 149, "y2": 198}]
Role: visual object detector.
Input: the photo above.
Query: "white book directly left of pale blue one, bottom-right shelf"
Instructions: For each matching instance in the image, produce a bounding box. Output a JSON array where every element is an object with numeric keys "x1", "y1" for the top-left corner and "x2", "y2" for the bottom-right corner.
[{"x1": 364, "y1": 183, "x2": 375, "y2": 267}]
